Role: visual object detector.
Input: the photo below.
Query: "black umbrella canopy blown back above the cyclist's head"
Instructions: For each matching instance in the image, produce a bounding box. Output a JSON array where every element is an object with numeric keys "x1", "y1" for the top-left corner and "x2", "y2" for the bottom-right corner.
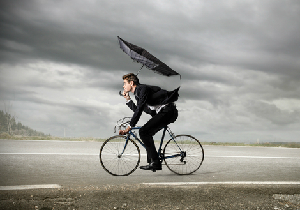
[{"x1": 118, "y1": 36, "x2": 180, "y2": 77}]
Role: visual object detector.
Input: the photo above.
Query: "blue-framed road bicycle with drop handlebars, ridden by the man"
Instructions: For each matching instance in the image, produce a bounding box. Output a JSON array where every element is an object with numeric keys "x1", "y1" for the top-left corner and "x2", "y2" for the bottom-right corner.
[{"x1": 99, "y1": 117, "x2": 204, "y2": 176}]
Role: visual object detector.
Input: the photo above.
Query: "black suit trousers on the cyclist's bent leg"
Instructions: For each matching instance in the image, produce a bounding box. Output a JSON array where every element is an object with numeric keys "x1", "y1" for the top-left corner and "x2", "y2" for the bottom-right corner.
[{"x1": 139, "y1": 103, "x2": 178, "y2": 163}]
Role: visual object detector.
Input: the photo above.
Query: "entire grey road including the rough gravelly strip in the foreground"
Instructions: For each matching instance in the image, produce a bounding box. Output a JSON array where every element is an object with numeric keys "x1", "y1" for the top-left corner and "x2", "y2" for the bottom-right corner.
[{"x1": 0, "y1": 140, "x2": 300, "y2": 210}]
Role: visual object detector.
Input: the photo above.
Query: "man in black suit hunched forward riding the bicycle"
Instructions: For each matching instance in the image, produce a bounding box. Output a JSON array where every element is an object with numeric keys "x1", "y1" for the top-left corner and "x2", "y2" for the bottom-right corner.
[{"x1": 119, "y1": 73, "x2": 179, "y2": 172}]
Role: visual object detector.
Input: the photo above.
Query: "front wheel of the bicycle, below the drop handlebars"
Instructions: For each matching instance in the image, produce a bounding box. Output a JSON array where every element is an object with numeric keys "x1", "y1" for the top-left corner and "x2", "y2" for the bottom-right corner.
[{"x1": 99, "y1": 135, "x2": 140, "y2": 176}]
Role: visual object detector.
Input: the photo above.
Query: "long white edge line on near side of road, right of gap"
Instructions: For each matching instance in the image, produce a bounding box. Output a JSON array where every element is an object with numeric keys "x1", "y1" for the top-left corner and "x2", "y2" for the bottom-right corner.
[{"x1": 142, "y1": 181, "x2": 300, "y2": 186}]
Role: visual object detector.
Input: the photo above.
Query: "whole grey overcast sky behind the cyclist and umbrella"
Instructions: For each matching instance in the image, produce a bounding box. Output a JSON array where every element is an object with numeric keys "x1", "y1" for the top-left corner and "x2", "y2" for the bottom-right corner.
[{"x1": 0, "y1": 0, "x2": 300, "y2": 142}]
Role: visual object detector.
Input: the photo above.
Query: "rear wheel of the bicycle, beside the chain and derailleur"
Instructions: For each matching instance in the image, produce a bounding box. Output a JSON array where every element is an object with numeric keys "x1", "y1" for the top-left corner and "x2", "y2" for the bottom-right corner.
[{"x1": 163, "y1": 135, "x2": 204, "y2": 175}]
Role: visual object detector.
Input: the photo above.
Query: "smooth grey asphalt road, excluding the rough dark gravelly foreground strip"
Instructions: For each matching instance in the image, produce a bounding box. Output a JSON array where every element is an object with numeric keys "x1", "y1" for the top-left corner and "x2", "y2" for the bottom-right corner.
[{"x1": 0, "y1": 140, "x2": 300, "y2": 187}]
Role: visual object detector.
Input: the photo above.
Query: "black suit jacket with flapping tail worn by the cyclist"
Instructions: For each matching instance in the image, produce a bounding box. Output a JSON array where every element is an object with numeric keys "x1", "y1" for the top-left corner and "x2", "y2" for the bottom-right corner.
[{"x1": 127, "y1": 84, "x2": 180, "y2": 127}]
